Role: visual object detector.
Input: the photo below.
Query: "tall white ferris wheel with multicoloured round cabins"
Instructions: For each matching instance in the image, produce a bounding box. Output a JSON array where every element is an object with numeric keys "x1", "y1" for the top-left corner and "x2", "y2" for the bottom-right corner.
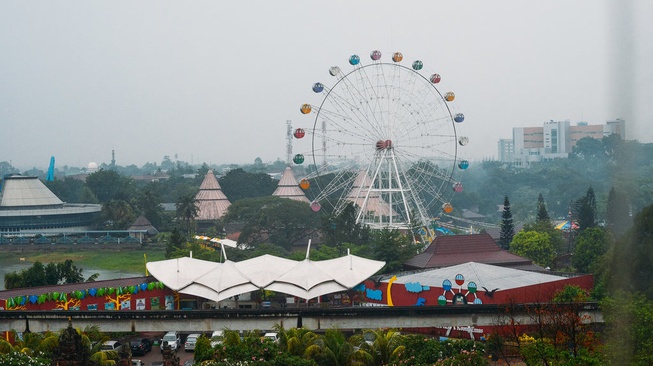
[{"x1": 293, "y1": 51, "x2": 469, "y2": 229}]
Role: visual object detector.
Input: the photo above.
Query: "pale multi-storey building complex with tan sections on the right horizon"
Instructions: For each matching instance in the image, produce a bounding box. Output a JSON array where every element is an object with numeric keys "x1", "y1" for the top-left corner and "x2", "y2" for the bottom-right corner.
[{"x1": 498, "y1": 118, "x2": 626, "y2": 166}]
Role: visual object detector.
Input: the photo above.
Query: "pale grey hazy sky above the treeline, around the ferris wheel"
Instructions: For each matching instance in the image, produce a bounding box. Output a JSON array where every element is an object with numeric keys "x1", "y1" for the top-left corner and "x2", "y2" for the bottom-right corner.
[{"x1": 0, "y1": 0, "x2": 653, "y2": 169}]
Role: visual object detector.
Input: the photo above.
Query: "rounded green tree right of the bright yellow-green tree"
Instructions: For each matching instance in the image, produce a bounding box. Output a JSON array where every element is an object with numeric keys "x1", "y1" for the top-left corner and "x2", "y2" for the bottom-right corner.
[{"x1": 571, "y1": 227, "x2": 611, "y2": 273}]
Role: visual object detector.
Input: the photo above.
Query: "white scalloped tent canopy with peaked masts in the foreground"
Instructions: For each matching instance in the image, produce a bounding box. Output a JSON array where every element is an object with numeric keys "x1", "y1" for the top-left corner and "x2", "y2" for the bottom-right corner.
[{"x1": 147, "y1": 251, "x2": 385, "y2": 302}]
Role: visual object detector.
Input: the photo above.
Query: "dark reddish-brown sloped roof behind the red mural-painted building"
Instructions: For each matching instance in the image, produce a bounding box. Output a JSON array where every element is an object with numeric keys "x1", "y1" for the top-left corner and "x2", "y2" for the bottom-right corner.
[{"x1": 404, "y1": 233, "x2": 543, "y2": 270}]
